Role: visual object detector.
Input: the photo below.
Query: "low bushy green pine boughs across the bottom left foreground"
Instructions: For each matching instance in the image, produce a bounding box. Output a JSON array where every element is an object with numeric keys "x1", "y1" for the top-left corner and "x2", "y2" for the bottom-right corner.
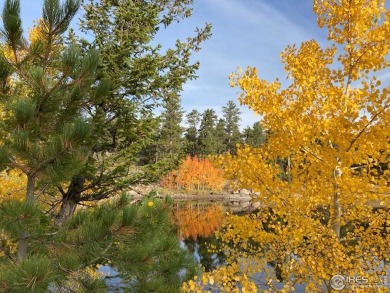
[{"x1": 0, "y1": 197, "x2": 196, "y2": 293}]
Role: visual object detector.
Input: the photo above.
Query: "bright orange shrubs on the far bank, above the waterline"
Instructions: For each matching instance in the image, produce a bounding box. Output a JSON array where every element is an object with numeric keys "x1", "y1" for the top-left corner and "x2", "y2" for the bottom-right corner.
[{"x1": 160, "y1": 156, "x2": 224, "y2": 191}]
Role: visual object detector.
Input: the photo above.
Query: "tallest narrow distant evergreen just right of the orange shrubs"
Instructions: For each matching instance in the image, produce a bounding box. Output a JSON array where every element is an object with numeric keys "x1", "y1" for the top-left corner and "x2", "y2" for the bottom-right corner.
[{"x1": 222, "y1": 101, "x2": 241, "y2": 153}]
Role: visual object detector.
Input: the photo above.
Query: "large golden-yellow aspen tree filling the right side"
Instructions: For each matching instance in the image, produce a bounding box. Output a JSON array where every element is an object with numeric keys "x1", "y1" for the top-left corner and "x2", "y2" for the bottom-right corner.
[{"x1": 183, "y1": 0, "x2": 390, "y2": 292}]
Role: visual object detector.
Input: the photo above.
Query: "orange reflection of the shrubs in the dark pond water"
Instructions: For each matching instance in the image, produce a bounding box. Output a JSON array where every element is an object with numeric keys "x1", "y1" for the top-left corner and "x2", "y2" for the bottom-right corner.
[{"x1": 172, "y1": 204, "x2": 225, "y2": 239}]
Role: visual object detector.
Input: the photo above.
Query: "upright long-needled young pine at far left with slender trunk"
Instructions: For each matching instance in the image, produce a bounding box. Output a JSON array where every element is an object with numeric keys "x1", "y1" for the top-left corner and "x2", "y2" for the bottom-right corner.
[{"x1": 0, "y1": 0, "x2": 96, "y2": 262}]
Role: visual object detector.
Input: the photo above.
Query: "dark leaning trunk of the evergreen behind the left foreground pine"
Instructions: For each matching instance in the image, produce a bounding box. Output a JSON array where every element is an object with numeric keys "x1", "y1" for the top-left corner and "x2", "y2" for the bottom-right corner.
[{"x1": 55, "y1": 176, "x2": 85, "y2": 226}]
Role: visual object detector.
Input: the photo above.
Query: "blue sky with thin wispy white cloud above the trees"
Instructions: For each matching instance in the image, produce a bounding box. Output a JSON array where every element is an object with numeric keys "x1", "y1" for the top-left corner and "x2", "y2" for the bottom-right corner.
[{"x1": 12, "y1": 0, "x2": 326, "y2": 128}]
